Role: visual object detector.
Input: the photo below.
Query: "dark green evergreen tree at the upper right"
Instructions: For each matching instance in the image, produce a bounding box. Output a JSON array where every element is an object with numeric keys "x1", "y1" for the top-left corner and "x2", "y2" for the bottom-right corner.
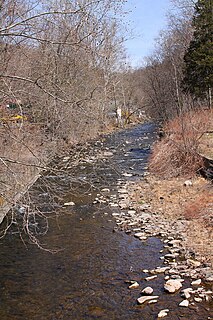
[{"x1": 183, "y1": 0, "x2": 213, "y2": 103}]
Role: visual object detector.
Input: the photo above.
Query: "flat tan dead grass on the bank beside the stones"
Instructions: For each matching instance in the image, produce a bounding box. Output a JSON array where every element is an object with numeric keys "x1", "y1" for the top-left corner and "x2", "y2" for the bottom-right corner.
[{"x1": 132, "y1": 175, "x2": 213, "y2": 266}]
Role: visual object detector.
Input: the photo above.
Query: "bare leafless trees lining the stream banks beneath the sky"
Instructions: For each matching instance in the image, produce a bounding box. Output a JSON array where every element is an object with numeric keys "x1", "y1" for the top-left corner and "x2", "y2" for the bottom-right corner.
[{"x1": 0, "y1": 0, "x2": 212, "y2": 244}]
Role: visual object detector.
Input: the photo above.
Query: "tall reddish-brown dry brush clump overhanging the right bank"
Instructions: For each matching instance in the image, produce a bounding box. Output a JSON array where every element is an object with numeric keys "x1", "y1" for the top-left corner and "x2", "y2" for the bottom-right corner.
[{"x1": 149, "y1": 110, "x2": 213, "y2": 178}]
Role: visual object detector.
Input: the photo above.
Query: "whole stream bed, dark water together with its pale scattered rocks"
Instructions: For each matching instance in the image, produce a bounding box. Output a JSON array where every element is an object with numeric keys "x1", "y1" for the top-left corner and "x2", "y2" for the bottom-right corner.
[{"x1": 0, "y1": 124, "x2": 213, "y2": 320}]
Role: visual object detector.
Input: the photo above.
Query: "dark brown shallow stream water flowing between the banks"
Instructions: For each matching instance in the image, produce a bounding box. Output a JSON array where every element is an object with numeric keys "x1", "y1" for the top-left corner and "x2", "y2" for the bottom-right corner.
[{"x1": 0, "y1": 124, "x2": 213, "y2": 320}]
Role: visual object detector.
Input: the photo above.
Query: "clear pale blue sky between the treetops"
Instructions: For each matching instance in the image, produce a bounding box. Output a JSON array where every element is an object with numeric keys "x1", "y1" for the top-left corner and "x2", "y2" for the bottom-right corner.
[{"x1": 125, "y1": 0, "x2": 171, "y2": 67}]
